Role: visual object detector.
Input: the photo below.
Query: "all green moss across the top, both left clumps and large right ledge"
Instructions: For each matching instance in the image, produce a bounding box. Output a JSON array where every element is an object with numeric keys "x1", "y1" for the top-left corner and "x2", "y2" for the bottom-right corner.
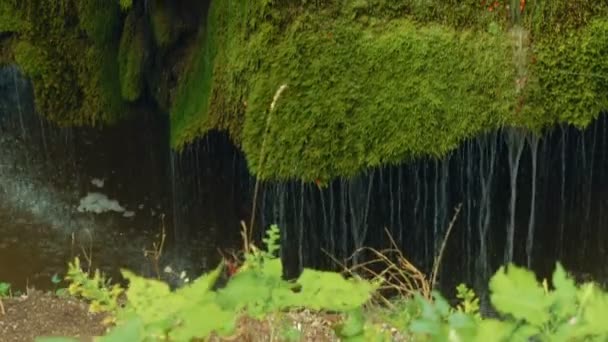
[{"x1": 0, "y1": 0, "x2": 608, "y2": 181}]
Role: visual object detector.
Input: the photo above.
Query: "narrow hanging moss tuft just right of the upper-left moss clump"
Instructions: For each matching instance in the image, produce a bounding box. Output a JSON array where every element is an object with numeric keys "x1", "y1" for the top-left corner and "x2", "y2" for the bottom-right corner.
[{"x1": 118, "y1": 12, "x2": 145, "y2": 101}]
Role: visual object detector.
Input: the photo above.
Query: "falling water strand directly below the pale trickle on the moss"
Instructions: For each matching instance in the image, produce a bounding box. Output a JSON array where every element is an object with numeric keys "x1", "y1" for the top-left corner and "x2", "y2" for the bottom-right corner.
[{"x1": 504, "y1": 130, "x2": 524, "y2": 263}]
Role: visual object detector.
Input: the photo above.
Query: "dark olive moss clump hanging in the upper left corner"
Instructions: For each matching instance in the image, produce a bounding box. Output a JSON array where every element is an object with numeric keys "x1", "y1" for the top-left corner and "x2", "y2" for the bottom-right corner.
[{"x1": 7, "y1": 0, "x2": 125, "y2": 126}]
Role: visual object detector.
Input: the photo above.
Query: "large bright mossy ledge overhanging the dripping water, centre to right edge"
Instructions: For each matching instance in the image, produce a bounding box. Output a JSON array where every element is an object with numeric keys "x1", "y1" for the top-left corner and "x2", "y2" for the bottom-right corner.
[{"x1": 171, "y1": 0, "x2": 608, "y2": 181}]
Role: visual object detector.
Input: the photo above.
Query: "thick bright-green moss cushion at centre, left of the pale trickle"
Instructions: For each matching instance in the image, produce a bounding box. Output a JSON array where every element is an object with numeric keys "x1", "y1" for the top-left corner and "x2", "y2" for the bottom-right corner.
[{"x1": 243, "y1": 19, "x2": 515, "y2": 180}]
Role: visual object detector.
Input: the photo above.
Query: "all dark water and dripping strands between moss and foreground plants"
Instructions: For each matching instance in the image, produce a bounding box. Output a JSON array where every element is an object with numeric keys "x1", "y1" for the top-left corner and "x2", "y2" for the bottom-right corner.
[{"x1": 0, "y1": 67, "x2": 608, "y2": 300}]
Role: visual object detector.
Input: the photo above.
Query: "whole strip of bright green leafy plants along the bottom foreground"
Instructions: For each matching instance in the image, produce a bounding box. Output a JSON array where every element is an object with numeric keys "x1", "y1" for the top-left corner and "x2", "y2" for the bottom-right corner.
[{"x1": 34, "y1": 226, "x2": 608, "y2": 341}]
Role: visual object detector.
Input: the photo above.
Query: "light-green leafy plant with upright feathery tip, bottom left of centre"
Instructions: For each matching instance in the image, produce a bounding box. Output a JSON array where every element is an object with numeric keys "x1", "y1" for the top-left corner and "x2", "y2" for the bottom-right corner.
[{"x1": 95, "y1": 226, "x2": 376, "y2": 341}]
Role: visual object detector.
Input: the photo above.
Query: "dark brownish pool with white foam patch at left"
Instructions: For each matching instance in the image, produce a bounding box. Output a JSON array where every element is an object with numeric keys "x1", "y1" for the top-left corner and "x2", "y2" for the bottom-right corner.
[{"x1": 0, "y1": 103, "x2": 240, "y2": 289}]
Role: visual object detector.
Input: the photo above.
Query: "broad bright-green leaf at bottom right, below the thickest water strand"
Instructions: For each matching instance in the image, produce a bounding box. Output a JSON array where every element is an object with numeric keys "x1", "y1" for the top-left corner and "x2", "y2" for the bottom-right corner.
[{"x1": 490, "y1": 264, "x2": 551, "y2": 326}]
